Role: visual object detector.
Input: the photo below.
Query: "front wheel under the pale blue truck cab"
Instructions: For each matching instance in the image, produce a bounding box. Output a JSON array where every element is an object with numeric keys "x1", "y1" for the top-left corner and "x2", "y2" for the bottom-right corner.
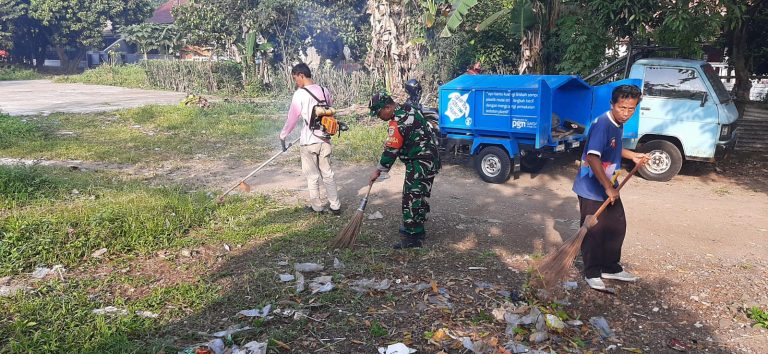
[{"x1": 639, "y1": 140, "x2": 683, "y2": 182}]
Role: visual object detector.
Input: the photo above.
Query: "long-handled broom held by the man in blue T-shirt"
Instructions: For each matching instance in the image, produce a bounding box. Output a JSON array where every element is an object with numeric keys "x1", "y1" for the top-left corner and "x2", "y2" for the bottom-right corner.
[{"x1": 536, "y1": 164, "x2": 640, "y2": 287}]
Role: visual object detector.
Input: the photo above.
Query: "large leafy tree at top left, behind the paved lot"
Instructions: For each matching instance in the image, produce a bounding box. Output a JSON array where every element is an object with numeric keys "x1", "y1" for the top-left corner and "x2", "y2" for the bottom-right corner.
[{"x1": 29, "y1": 0, "x2": 152, "y2": 72}]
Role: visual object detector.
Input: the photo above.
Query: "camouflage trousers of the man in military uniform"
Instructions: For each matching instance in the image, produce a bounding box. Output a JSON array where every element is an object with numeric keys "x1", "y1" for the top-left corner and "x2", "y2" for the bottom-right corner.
[{"x1": 403, "y1": 160, "x2": 440, "y2": 235}]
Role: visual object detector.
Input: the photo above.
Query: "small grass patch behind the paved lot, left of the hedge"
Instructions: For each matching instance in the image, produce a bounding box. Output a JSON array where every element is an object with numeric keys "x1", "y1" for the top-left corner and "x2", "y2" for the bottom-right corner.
[{"x1": 54, "y1": 64, "x2": 151, "y2": 88}]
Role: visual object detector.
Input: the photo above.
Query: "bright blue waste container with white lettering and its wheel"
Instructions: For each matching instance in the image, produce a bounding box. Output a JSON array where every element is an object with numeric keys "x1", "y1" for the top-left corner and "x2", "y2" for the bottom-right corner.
[{"x1": 439, "y1": 75, "x2": 640, "y2": 183}]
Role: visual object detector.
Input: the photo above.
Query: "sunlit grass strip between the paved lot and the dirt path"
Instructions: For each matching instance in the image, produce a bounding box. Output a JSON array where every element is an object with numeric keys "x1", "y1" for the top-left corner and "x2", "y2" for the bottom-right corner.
[{"x1": 0, "y1": 103, "x2": 386, "y2": 165}]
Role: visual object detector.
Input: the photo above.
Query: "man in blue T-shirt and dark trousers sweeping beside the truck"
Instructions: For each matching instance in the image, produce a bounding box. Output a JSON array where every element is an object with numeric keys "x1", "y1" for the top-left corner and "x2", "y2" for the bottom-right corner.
[{"x1": 573, "y1": 85, "x2": 648, "y2": 290}]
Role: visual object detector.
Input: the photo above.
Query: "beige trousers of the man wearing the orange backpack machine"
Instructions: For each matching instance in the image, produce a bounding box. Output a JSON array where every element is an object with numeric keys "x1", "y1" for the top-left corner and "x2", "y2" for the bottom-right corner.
[{"x1": 301, "y1": 142, "x2": 341, "y2": 211}]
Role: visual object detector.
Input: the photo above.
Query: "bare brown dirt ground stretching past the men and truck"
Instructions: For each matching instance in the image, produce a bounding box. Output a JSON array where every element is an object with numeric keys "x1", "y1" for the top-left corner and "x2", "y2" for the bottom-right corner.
[{"x1": 10, "y1": 151, "x2": 768, "y2": 353}]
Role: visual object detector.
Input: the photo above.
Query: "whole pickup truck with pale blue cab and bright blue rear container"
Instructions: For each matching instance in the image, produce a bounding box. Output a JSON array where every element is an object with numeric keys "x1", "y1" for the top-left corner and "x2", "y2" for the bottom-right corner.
[{"x1": 438, "y1": 58, "x2": 738, "y2": 183}]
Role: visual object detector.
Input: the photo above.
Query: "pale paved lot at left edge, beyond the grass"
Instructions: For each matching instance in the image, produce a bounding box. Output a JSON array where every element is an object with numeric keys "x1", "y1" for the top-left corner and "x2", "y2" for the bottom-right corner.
[{"x1": 0, "y1": 80, "x2": 186, "y2": 116}]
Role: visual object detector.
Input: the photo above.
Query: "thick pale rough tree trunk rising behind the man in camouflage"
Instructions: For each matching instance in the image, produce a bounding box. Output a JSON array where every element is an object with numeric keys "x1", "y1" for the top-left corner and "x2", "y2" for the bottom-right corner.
[{"x1": 365, "y1": 0, "x2": 426, "y2": 97}]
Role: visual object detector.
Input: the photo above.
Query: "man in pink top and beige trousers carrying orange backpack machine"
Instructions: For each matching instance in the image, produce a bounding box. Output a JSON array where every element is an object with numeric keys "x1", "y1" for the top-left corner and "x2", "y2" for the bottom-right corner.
[{"x1": 279, "y1": 63, "x2": 341, "y2": 215}]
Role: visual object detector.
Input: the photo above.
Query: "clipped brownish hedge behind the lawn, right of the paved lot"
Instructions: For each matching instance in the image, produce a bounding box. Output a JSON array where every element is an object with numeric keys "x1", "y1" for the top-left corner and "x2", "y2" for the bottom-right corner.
[{"x1": 142, "y1": 60, "x2": 243, "y2": 93}]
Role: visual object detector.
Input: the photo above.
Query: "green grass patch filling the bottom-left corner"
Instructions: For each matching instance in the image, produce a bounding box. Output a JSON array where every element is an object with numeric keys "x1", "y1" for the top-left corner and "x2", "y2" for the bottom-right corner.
[{"x1": 0, "y1": 281, "x2": 220, "y2": 353}]
